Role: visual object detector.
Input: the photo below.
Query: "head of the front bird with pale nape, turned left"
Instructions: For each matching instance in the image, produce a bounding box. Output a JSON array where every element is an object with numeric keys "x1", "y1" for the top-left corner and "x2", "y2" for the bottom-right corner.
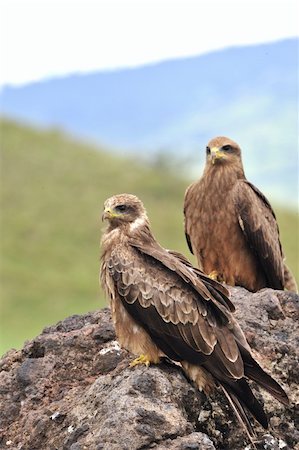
[{"x1": 102, "y1": 194, "x2": 147, "y2": 228}]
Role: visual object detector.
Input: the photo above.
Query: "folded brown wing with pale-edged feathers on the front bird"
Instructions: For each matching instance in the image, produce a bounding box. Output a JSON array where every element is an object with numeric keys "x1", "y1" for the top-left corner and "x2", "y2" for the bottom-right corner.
[{"x1": 108, "y1": 241, "x2": 244, "y2": 379}]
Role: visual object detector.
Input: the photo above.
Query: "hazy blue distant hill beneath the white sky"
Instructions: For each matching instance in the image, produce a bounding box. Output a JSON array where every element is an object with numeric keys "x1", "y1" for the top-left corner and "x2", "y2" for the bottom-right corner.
[{"x1": 0, "y1": 39, "x2": 298, "y2": 205}]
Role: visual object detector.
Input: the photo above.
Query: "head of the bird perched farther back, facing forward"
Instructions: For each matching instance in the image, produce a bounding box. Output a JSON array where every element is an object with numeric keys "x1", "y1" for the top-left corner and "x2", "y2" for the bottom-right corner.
[{"x1": 206, "y1": 136, "x2": 241, "y2": 166}]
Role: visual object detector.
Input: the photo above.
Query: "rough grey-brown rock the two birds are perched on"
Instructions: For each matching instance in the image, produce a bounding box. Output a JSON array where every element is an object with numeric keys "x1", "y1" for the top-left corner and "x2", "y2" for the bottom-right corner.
[{"x1": 0, "y1": 288, "x2": 299, "y2": 450}]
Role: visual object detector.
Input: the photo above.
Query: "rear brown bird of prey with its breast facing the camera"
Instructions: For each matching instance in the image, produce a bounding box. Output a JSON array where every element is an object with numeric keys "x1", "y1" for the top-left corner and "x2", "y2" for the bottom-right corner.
[{"x1": 184, "y1": 136, "x2": 297, "y2": 292}]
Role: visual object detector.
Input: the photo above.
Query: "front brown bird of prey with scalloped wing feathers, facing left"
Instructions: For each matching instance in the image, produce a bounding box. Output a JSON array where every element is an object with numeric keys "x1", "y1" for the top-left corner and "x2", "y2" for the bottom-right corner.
[{"x1": 100, "y1": 194, "x2": 288, "y2": 436}]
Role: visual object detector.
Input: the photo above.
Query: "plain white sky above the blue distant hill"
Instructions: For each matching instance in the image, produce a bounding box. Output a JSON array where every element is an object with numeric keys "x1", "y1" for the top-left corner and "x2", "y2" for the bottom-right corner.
[{"x1": 0, "y1": 0, "x2": 299, "y2": 86}]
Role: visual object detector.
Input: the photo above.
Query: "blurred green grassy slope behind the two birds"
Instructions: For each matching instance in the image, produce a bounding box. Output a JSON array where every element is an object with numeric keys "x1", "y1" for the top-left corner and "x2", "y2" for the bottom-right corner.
[{"x1": 0, "y1": 121, "x2": 299, "y2": 353}]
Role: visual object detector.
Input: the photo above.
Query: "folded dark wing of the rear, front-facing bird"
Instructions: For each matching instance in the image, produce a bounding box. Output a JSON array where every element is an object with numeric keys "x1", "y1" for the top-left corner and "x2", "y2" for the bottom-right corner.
[{"x1": 233, "y1": 180, "x2": 284, "y2": 289}]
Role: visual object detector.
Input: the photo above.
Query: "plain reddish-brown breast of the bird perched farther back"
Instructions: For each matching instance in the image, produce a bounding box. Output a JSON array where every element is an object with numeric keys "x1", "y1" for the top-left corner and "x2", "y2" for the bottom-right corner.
[{"x1": 186, "y1": 180, "x2": 258, "y2": 288}]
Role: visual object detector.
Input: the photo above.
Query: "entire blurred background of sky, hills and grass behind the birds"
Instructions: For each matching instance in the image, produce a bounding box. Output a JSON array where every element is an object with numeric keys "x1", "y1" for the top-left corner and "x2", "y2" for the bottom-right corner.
[{"x1": 0, "y1": 0, "x2": 299, "y2": 354}]
